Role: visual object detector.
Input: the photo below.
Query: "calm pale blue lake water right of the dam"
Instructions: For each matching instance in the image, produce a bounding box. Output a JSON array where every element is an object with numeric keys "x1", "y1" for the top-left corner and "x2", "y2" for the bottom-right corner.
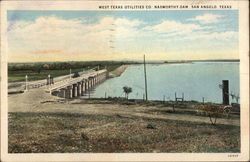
[{"x1": 92, "y1": 62, "x2": 239, "y2": 103}]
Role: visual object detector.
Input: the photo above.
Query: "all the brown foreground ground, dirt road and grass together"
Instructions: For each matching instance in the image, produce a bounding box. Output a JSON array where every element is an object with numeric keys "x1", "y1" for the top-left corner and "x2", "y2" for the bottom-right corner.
[{"x1": 8, "y1": 89, "x2": 240, "y2": 153}]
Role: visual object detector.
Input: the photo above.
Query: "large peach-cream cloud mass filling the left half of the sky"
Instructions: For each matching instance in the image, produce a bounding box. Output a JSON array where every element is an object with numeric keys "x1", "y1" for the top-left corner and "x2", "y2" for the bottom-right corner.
[{"x1": 8, "y1": 16, "x2": 143, "y2": 60}]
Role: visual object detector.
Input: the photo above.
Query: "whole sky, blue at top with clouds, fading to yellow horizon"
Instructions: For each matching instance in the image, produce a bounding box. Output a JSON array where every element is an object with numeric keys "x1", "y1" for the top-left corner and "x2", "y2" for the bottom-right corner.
[{"x1": 7, "y1": 10, "x2": 239, "y2": 62}]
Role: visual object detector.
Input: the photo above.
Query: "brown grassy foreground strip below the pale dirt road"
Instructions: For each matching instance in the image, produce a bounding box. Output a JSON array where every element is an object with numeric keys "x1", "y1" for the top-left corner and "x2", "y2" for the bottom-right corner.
[{"x1": 8, "y1": 112, "x2": 240, "y2": 153}]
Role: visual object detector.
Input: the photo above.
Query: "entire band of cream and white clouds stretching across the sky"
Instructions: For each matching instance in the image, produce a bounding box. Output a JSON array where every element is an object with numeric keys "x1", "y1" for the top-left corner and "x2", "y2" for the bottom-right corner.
[{"x1": 8, "y1": 16, "x2": 238, "y2": 60}]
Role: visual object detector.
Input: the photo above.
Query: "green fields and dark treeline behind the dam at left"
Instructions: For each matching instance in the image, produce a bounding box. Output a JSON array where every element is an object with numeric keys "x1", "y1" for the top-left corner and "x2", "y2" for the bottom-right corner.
[{"x1": 8, "y1": 61, "x2": 139, "y2": 82}]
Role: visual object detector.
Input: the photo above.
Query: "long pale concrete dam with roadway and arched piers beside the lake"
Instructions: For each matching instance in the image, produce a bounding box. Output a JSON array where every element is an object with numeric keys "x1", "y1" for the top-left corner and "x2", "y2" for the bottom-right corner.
[{"x1": 25, "y1": 69, "x2": 108, "y2": 99}]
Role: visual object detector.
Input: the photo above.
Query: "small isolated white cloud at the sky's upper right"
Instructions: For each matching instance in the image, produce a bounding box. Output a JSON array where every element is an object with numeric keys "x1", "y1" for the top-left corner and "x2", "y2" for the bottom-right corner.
[{"x1": 188, "y1": 13, "x2": 223, "y2": 24}]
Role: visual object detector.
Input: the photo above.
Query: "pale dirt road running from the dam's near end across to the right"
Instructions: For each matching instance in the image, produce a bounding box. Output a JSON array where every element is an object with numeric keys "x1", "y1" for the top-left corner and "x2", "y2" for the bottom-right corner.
[{"x1": 8, "y1": 89, "x2": 240, "y2": 126}]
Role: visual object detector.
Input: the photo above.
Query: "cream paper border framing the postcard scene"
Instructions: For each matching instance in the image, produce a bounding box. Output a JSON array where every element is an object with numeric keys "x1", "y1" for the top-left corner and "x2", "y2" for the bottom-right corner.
[{"x1": 0, "y1": 0, "x2": 249, "y2": 161}]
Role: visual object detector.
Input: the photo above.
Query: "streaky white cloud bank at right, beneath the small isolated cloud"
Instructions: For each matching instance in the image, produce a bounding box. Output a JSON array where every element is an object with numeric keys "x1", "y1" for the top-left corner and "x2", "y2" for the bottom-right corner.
[{"x1": 144, "y1": 17, "x2": 238, "y2": 44}]
